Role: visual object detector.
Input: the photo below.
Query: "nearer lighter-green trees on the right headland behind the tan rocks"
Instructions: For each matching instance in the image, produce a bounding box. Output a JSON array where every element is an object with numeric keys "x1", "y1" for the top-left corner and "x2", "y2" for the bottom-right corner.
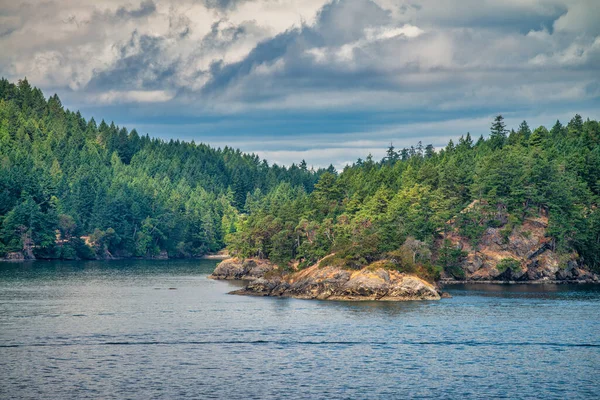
[{"x1": 226, "y1": 115, "x2": 600, "y2": 273}]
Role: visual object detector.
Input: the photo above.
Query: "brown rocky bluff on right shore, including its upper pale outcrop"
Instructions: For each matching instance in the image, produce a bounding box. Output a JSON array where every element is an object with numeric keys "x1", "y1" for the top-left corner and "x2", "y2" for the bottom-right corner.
[{"x1": 437, "y1": 206, "x2": 600, "y2": 284}]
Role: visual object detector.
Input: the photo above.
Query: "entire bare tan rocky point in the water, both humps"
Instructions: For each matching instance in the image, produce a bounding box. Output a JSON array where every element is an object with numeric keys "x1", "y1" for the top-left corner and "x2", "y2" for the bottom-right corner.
[{"x1": 210, "y1": 259, "x2": 441, "y2": 301}]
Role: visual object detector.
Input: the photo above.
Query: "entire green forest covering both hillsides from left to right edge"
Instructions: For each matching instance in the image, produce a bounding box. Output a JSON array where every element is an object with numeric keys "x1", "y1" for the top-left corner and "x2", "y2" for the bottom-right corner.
[{"x1": 0, "y1": 79, "x2": 600, "y2": 276}]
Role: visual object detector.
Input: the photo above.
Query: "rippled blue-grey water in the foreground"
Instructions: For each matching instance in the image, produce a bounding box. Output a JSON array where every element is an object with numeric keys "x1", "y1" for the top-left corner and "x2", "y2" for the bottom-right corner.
[{"x1": 0, "y1": 261, "x2": 600, "y2": 399}]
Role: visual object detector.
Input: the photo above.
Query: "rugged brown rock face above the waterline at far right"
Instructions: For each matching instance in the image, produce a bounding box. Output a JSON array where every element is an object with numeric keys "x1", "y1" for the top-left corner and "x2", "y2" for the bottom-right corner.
[{"x1": 442, "y1": 205, "x2": 600, "y2": 283}]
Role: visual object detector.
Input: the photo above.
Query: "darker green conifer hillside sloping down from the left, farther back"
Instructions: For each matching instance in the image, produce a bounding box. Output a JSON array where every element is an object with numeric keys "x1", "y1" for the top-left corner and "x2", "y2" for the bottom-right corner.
[{"x1": 0, "y1": 79, "x2": 323, "y2": 259}]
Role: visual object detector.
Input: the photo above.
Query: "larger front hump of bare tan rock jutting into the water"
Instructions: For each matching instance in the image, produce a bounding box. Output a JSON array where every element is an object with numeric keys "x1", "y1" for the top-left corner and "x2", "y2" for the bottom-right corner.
[{"x1": 227, "y1": 265, "x2": 440, "y2": 301}]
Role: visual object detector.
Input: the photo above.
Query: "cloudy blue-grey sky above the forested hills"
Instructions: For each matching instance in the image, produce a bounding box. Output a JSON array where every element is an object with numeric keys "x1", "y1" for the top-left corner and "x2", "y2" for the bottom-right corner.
[{"x1": 0, "y1": 0, "x2": 600, "y2": 169}]
